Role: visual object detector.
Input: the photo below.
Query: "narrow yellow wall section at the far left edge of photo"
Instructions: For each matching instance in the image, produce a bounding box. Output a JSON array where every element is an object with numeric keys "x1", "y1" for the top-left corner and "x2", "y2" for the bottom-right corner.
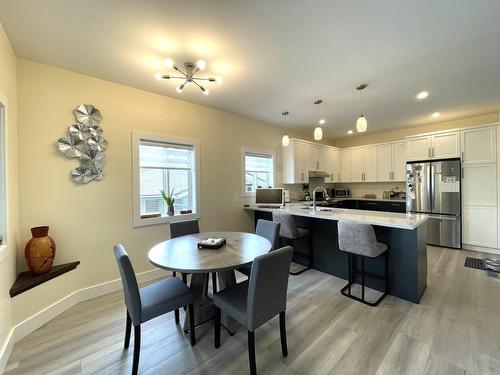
[{"x1": 0, "y1": 24, "x2": 18, "y2": 372}]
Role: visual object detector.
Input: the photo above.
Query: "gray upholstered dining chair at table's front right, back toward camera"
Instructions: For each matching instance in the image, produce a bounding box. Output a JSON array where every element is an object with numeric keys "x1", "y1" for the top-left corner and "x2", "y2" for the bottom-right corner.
[{"x1": 213, "y1": 246, "x2": 293, "y2": 375}]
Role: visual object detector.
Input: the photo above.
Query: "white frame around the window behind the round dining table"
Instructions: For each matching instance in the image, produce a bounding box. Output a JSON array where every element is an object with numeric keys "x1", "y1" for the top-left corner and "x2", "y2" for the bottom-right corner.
[{"x1": 132, "y1": 130, "x2": 201, "y2": 227}]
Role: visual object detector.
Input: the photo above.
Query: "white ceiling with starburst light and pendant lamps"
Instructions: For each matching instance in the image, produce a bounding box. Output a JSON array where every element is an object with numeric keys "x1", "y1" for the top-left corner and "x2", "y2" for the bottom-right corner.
[{"x1": 0, "y1": 0, "x2": 500, "y2": 138}]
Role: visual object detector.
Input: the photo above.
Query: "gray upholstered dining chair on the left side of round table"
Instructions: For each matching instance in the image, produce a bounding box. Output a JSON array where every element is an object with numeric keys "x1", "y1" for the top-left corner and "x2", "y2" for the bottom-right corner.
[{"x1": 113, "y1": 245, "x2": 196, "y2": 374}]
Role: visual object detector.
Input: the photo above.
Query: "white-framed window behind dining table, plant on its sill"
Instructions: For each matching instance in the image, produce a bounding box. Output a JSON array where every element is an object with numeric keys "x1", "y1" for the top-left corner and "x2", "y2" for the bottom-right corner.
[{"x1": 133, "y1": 132, "x2": 200, "y2": 226}]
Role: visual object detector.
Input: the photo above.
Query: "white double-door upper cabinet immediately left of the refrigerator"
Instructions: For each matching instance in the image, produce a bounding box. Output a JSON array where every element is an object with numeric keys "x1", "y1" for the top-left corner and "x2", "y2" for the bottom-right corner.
[{"x1": 377, "y1": 142, "x2": 406, "y2": 181}]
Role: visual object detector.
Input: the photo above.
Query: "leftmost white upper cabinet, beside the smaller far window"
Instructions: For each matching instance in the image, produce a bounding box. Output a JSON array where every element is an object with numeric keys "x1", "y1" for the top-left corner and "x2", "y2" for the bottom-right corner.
[{"x1": 282, "y1": 139, "x2": 309, "y2": 184}]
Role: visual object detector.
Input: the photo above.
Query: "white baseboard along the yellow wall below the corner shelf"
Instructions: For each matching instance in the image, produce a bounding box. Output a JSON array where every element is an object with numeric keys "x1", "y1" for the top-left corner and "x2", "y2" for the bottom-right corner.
[{"x1": 0, "y1": 269, "x2": 171, "y2": 374}]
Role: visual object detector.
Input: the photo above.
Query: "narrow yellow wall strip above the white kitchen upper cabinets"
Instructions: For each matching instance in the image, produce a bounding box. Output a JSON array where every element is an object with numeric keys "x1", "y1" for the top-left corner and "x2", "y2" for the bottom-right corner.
[{"x1": 332, "y1": 113, "x2": 499, "y2": 147}]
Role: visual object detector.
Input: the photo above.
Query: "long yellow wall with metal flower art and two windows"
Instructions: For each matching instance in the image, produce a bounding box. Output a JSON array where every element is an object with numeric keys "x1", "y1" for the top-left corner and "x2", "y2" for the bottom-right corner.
[{"x1": 13, "y1": 59, "x2": 306, "y2": 323}]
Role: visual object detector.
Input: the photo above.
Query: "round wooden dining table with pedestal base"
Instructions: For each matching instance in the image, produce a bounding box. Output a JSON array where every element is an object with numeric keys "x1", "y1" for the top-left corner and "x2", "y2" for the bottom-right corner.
[{"x1": 148, "y1": 231, "x2": 272, "y2": 334}]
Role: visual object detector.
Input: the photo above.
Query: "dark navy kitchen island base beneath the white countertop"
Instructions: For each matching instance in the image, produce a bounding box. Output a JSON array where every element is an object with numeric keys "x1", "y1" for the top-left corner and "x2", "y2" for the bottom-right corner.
[{"x1": 255, "y1": 211, "x2": 427, "y2": 303}]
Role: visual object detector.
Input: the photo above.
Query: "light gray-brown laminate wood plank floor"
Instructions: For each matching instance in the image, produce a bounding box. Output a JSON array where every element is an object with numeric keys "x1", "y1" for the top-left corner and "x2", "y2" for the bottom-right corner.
[{"x1": 5, "y1": 247, "x2": 500, "y2": 375}]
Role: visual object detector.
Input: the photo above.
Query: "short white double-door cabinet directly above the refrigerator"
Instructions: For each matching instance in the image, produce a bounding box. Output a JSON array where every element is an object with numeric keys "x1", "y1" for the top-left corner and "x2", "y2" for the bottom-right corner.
[{"x1": 406, "y1": 131, "x2": 460, "y2": 161}]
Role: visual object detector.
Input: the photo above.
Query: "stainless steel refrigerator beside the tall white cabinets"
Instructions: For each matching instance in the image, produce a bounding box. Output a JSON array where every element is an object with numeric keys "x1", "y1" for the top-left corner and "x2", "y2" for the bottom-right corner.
[{"x1": 406, "y1": 159, "x2": 462, "y2": 249}]
